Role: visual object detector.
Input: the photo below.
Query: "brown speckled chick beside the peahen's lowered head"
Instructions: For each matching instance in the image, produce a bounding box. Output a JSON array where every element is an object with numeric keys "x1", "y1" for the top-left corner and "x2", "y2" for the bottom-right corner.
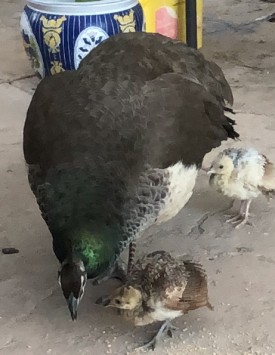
[{"x1": 101, "y1": 251, "x2": 213, "y2": 349}]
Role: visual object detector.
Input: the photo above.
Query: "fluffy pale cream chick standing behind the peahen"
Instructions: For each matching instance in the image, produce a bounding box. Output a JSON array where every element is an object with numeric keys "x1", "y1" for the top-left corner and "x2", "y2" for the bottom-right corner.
[{"x1": 208, "y1": 148, "x2": 275, "y2": 228}]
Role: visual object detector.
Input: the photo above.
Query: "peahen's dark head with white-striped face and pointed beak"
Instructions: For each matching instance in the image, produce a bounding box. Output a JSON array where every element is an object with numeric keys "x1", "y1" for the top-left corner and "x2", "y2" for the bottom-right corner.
[{"x1": 58, "y1": 260, "x2": 87, "y2": 321}]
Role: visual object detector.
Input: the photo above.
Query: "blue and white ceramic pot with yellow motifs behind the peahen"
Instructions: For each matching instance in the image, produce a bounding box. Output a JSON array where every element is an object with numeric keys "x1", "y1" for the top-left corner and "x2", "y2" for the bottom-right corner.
[{"x1": 20, "y1": 0, "x2": 144, "y2": 78}]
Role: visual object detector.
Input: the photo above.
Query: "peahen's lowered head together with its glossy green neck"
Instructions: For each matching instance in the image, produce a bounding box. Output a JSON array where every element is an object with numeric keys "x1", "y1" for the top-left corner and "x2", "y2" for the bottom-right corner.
[{"x1": 55, "y1": 222, "x2": 121, "y2": 320}]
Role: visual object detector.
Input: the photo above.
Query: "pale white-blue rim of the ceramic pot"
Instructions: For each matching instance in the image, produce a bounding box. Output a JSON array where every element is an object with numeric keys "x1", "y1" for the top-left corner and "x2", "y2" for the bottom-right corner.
[{"x1": 26, "y1": 0, "x2": 139, "y2": 16}]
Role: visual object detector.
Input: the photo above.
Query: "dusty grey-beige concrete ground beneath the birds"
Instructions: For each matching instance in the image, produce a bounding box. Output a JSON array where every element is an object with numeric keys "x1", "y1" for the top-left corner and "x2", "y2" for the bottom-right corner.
[{"x1": 0, "y1": 0, "x2": 275, "y2": 355}]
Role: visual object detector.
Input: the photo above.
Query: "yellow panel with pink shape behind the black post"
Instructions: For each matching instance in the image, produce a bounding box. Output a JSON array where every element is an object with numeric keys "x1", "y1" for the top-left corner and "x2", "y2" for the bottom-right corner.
[{"x1": 140, "y1": 0, "x2": 203, "y2": 48}]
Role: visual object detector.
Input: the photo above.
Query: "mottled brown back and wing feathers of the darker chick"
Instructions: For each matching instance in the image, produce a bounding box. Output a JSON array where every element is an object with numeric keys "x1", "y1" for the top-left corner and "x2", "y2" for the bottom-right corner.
[{"x1": 129, "y1": 251, "x2": 213, "y2": 313}]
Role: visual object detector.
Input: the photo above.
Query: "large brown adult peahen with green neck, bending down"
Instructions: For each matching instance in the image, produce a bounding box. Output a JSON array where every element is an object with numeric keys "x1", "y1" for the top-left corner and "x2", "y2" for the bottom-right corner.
[{"x1": 24, "y1": 33, "x2": 238, "y2": 320}]
